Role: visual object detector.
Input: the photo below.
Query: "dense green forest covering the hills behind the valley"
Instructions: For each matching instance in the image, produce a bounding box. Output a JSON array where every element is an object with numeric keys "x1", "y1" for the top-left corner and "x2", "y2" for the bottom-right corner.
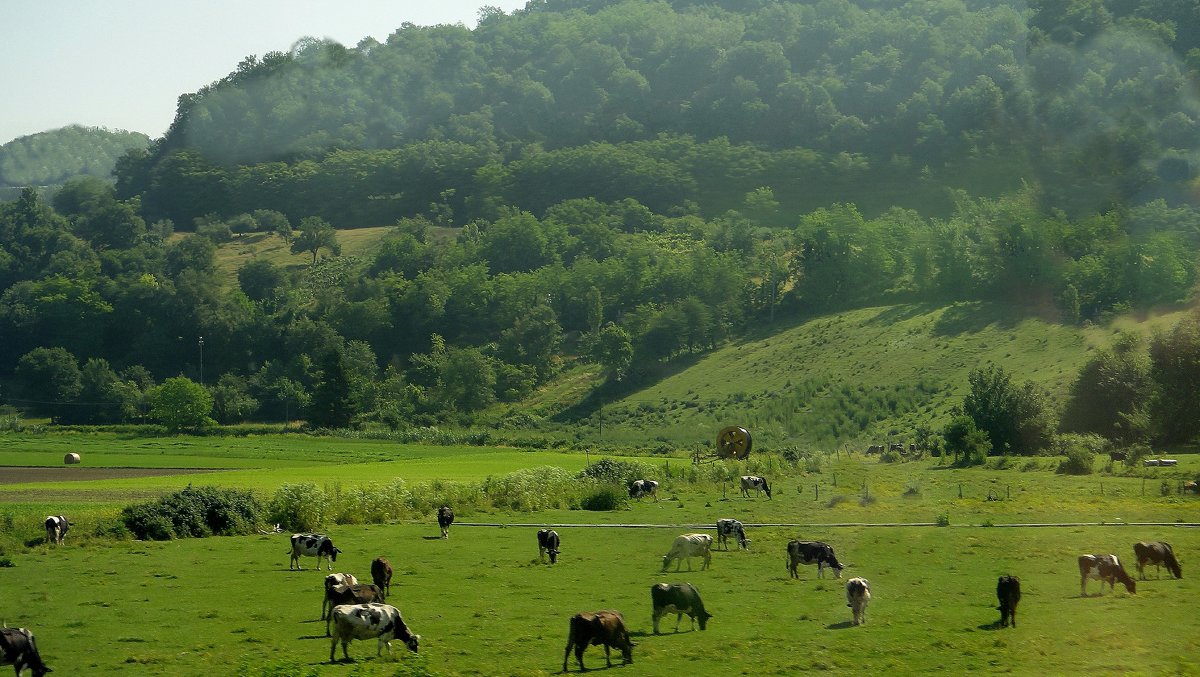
[{"x1": 0, "y1": 0, "x2": 1200, "y2": 453}]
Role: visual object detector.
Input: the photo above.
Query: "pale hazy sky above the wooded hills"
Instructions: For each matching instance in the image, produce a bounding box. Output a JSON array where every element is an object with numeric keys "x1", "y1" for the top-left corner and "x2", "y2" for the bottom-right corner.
[{"x1": 0, "y1": 0, "x2": 526, "y2": 145}]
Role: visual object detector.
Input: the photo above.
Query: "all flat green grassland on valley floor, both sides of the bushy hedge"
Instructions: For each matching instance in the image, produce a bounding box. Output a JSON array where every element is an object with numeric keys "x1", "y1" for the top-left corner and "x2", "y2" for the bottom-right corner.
[{"x1": 0, "y1": 435, "x2": 1200, "y2": 676}]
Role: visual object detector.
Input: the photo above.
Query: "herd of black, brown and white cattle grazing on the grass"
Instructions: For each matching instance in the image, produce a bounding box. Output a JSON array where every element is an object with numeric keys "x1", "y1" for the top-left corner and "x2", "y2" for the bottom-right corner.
[{"x1": 0, "y1": 487, "x2": 1183, "y2": 677}]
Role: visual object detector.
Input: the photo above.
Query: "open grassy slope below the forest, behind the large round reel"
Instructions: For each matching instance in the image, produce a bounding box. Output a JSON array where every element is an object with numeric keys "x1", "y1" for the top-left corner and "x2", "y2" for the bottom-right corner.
[{"x1": 568, "y1": 302, "x2": 1186, "y2": 450}]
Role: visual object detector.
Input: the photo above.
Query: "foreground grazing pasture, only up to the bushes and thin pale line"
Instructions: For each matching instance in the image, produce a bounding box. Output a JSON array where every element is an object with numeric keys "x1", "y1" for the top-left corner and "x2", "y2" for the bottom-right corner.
[{"x1": 0, "y1": 520, "x2": 1200, "y2": 676}]
